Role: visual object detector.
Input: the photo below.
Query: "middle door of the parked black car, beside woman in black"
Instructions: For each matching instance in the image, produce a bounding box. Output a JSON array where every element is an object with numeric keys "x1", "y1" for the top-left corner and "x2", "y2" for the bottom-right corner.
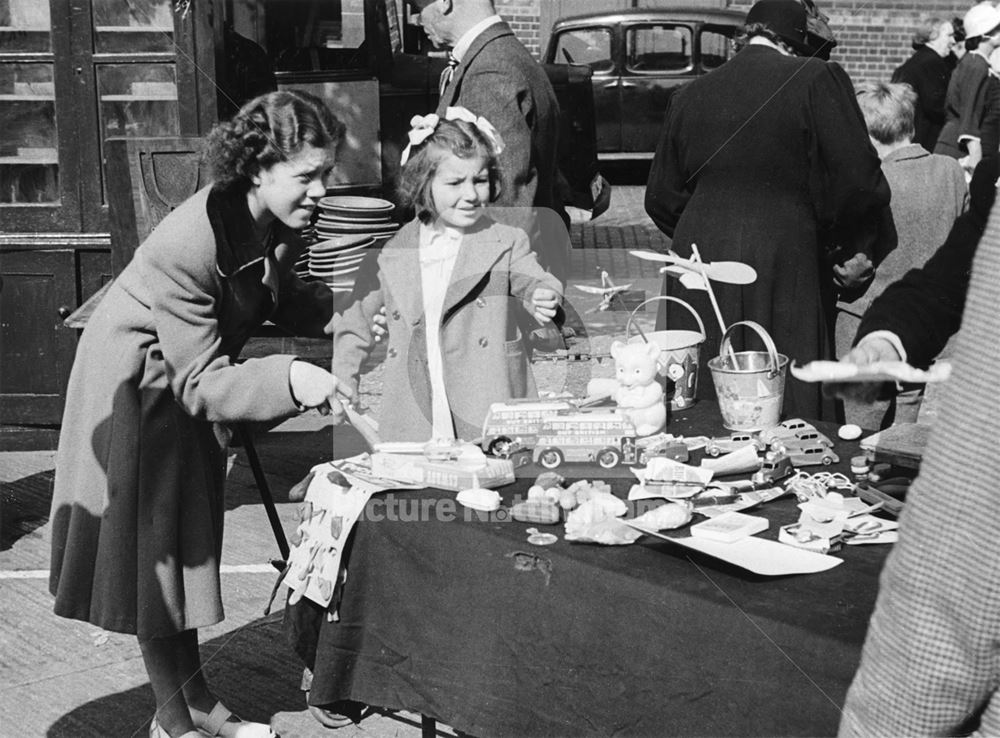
[{"x1": 620, "y1": 21, "x2": 697, "y2": 156}]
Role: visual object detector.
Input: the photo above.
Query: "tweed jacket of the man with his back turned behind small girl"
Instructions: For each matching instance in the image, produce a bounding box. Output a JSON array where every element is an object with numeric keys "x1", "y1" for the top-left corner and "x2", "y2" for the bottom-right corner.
[{"x1": 437, "y1": 21, "x2": 569, "y2": 276}]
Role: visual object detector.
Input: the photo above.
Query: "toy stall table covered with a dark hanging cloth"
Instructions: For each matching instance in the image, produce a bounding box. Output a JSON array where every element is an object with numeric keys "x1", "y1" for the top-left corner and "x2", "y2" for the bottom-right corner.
[{"x1": 286, "y1": 403, "x2": 889, "y2": 736}]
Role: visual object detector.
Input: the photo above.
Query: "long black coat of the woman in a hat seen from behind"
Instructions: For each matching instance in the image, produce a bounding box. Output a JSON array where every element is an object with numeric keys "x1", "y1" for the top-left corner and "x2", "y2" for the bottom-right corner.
[{"x1": 645, "y1": 45, "x2": 891, "y2": 420}]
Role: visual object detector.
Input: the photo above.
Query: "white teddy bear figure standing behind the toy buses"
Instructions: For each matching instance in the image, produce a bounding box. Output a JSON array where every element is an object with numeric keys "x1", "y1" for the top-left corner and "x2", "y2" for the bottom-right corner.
[{"x1": 587, "y1": 341, "x2": 667, "y2": 436}]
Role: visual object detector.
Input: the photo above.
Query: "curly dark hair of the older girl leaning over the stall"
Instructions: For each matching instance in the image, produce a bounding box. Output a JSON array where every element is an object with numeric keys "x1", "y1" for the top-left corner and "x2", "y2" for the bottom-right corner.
[{"x1": 204, "y1": 90, "x2": 344, "y2": 188}]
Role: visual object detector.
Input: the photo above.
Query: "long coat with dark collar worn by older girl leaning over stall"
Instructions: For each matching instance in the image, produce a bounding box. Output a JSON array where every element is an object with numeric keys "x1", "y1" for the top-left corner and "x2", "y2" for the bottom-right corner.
[{"x1": 49, "y1": 188, "x2": 333, "y2": 639}]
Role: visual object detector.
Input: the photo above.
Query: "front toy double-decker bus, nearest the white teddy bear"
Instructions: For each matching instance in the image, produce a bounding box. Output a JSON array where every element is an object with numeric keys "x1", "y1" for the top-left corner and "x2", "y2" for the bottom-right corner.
[{"x1": 532, "y1": 410, "x2": 642, "y2": 469}]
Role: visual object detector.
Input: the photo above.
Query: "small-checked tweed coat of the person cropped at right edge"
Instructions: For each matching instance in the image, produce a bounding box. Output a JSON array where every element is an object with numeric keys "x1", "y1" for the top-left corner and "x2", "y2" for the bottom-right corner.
[{"x1": 840, "y1": 193, "x2": 1000, "y2": 738}]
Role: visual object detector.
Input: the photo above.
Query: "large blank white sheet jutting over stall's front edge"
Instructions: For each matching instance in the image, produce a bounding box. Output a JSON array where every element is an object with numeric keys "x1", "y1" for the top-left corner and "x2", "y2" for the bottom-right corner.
[{"x1": 623, "y1": 521, "x2": 843, "y2": 577}]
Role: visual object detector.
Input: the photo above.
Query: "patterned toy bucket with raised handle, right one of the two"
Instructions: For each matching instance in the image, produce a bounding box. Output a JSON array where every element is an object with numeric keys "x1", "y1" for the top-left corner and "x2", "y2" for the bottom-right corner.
[{"x1": 708, "y1": 320, "x2": 788, "y2": 431}]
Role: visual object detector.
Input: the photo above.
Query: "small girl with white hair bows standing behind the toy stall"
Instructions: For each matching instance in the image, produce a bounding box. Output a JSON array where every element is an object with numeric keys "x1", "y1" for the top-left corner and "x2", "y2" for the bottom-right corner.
[{"x1": 333, "y1": 108, "x2": 562, "y2": 441}]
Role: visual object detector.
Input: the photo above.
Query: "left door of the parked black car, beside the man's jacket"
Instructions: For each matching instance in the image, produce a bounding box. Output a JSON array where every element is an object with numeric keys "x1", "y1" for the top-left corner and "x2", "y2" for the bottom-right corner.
[{"x1": 550, "y1": 25, "x2": 622, "y2": 153}]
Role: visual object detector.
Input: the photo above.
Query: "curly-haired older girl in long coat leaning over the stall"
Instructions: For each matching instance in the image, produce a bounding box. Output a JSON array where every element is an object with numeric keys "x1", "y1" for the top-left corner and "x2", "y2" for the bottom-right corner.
[{"x1": 50, "y1": 92, "x2": 356, "y2": 737}]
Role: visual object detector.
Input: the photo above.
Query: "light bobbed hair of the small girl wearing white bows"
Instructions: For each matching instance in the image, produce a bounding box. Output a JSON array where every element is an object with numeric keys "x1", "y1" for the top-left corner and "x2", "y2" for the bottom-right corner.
[{"x1": 397, "y1": 119, "x2": 500, "y2": 223}]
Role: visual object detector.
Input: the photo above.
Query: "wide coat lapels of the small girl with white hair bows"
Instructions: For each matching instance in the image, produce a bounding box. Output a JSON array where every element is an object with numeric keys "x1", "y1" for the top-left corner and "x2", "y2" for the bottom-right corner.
[{"x1": 379, "y1": 217, "x2": 506, "y2": 325}]
